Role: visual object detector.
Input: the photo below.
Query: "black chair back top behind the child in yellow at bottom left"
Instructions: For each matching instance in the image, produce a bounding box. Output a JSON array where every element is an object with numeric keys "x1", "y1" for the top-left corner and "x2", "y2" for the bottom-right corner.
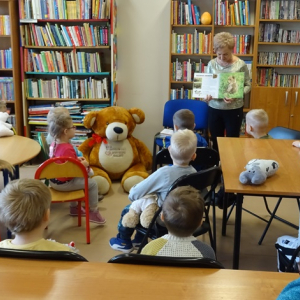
[{"x1": 0, "y1": 248, "x2": 87, "y2": 261}]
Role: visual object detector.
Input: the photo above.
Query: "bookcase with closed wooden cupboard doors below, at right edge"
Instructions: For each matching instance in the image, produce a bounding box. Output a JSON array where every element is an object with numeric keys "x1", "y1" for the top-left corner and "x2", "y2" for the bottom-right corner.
[{"x1": 251, "y1": 0, "x2": 300, "y2": 130}]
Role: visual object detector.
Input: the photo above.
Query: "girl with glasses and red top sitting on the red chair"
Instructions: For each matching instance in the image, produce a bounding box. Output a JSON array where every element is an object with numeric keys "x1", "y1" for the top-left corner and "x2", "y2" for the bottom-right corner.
[{"x1": 47, "y1": 107, "x2": 106, "y2": 225}]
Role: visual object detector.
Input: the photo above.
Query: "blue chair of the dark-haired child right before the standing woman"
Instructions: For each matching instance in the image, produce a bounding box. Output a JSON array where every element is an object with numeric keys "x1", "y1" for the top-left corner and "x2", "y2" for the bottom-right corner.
[{"x1": 153, "y1": 99, "x2": 208, "y2": 168}]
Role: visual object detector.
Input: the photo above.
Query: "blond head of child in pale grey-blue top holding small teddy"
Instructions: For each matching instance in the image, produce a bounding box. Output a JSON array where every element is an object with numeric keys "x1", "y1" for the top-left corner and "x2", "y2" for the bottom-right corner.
[{"x1": 169, "y1": 129, "x2": 197, "y2": 165}]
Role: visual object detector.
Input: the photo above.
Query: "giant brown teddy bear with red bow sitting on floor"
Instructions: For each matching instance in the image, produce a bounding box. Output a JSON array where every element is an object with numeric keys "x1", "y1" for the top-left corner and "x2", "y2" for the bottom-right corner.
[{"x1": 78, "y1": 106, "x2": 152, "y2": 195}]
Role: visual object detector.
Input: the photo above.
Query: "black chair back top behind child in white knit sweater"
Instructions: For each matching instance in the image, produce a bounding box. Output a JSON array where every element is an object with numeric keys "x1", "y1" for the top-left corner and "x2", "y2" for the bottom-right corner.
[{"x1": 108, "y1": 253, "x2": 224, "y2": 269}]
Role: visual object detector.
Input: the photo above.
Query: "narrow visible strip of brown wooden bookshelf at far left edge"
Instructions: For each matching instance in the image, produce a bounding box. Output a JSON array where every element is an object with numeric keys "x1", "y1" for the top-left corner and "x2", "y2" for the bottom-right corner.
[{"x1": 0, "y1": 0, "x2": 23, "y2": 134}]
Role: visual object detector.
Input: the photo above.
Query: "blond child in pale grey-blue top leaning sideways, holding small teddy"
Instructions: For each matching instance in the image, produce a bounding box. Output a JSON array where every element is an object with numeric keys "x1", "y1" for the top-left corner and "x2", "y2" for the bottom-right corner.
[{"x1": 109, "y1": 129, "x2": 197, "y2": 253}]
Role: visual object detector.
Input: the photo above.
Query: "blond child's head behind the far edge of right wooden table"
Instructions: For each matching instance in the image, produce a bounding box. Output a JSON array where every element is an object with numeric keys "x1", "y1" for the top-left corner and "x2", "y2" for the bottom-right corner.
[{"x1": 246, "y1": 109, "x2": 269, "y2": 138}]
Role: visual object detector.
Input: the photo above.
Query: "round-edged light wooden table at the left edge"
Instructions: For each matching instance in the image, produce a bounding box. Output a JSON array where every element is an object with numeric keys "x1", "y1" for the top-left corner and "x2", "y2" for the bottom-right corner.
[{"x1": 0, "y1": 135, "x2": 41, "y2": 185}]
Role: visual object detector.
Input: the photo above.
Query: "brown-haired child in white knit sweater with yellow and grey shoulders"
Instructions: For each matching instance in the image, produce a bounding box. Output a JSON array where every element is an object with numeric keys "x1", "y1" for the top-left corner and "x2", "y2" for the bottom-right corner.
[{"x1": 141, "y1": 186, "x2": 216, "y2": 259}]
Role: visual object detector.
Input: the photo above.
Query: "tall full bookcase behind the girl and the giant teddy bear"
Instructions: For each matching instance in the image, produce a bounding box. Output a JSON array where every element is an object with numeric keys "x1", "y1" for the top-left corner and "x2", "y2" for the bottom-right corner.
[{"x1": 19, "y1": 0, "x2": 117, "y2": 145}]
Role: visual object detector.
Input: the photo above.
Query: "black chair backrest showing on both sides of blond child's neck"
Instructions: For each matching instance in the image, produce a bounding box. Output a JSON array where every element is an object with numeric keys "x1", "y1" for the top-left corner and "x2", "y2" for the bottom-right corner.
[{"x1": 152, "y1": 148, "x2": 220, "y2": 172}]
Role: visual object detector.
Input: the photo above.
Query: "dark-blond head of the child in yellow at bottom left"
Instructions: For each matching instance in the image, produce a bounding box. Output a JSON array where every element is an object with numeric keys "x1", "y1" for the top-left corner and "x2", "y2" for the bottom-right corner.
[{"x1": 0, "y1": 178, "x2": 51, "y2": 234}]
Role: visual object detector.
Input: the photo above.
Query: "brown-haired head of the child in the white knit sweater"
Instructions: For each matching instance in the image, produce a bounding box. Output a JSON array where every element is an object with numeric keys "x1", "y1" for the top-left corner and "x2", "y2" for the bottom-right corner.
[{"x1": 162, "y1": 186, "x2": 204, "y2": 237}]
